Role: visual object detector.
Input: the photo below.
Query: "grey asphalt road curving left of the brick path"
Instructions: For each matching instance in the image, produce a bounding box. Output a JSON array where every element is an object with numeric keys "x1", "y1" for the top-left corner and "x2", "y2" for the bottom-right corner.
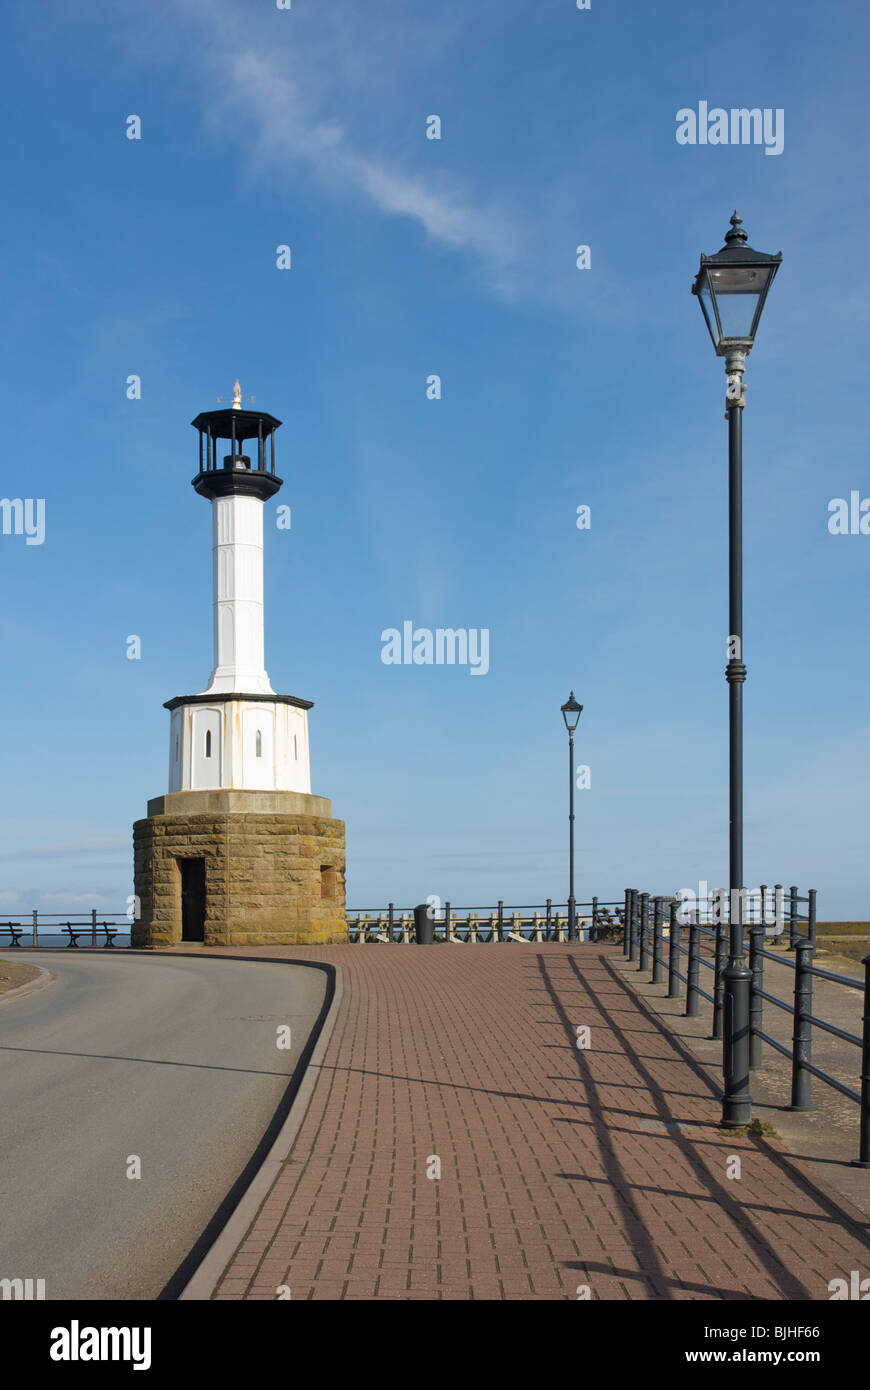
[{"x1": 0, "y1": 951, "x2": 325, "y2": 1300}]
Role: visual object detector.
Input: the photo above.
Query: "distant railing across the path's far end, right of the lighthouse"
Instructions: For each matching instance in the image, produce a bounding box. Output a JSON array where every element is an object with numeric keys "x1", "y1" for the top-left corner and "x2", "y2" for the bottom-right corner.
[{"x1": 347, "y1": 898, "x2": 623, "y2": 945}]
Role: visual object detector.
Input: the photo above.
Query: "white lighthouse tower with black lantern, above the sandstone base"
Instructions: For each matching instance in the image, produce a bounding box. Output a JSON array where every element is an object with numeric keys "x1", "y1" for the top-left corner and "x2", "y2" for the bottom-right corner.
[{"x1": 165, "y1": 381, "x2": 311, "y2": 794}]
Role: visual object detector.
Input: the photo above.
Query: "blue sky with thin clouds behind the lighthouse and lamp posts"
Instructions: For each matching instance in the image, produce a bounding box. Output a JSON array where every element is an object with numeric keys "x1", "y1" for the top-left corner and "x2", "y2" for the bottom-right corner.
[{"x1": 0, "y1": 0, "x2": 870, "y2": 917}]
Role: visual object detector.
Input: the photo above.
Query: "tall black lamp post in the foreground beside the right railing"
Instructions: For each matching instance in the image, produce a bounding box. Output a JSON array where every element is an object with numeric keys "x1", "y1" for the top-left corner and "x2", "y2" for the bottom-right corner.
[{"x1": 692, "y1": 213, "x2": 782, "y2": 1129}]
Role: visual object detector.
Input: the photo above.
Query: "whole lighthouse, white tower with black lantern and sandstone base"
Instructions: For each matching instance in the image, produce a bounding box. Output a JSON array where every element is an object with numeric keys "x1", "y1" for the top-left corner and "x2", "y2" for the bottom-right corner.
[{"x1": 132, "y1": 381, "x2": 347, "y2": 947}]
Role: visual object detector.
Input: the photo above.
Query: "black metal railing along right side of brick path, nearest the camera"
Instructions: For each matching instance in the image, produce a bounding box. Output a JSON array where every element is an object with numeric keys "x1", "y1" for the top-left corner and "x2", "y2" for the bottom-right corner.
[{"x1": 624, "y1": 885, "x2": 870, "y2": 1168}]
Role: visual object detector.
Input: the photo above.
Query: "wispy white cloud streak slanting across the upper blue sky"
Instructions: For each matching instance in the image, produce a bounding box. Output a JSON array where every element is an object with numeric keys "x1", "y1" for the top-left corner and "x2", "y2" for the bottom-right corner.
[{"x1": 111, "y1": 0, "x2": 524, "y2": 297}]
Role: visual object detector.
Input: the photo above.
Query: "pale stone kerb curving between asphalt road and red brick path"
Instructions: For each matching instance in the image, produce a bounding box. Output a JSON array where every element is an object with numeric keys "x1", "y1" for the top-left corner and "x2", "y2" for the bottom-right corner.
[{"x1": 177, "y1": 962, "x2": 345, "y2": 1302}]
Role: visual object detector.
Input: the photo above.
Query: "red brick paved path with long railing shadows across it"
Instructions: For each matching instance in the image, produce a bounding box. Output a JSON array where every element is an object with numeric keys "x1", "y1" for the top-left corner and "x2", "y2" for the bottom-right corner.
[{"x1": 195, "y1": 944, "x2": 870, "y2": 1300}]
